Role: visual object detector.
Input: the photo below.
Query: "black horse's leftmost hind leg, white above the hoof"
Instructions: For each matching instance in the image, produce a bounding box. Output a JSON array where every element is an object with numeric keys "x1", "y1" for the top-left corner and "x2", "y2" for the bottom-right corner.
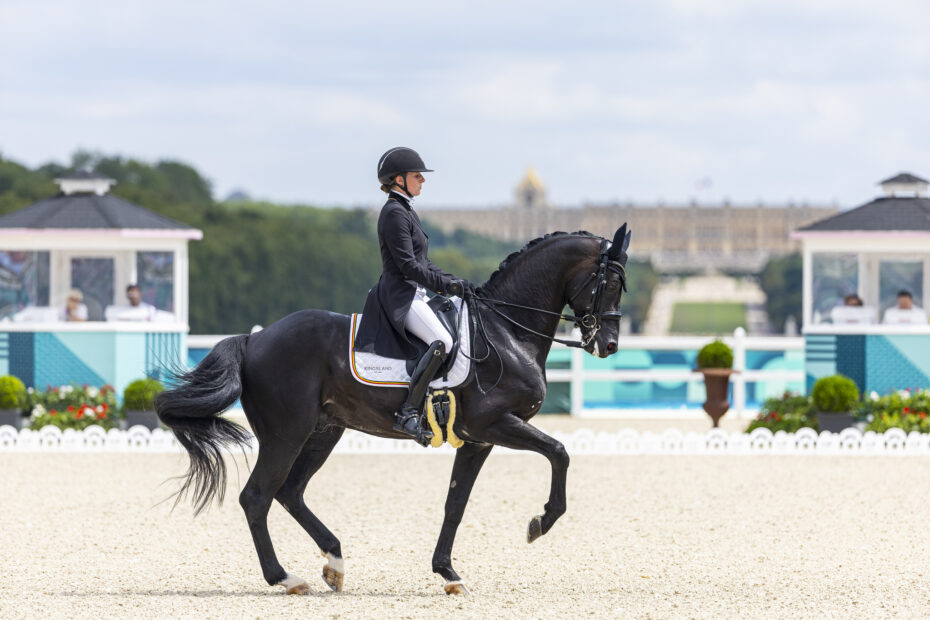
[{"x1": 239, "y1": 436, "x2": 310, "y2": 594}]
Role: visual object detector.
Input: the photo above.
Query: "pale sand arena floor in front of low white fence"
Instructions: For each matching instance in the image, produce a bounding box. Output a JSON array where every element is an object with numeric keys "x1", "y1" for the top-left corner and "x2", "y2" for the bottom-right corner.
[{"x1": 0, "y1": 446, "x2": 930, "y2": 619}]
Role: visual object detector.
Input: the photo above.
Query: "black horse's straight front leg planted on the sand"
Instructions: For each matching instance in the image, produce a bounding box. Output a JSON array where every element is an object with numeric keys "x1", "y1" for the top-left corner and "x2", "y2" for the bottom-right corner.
[{"x1": 433, "y1": 443, "x2": 492, "y2": 594}]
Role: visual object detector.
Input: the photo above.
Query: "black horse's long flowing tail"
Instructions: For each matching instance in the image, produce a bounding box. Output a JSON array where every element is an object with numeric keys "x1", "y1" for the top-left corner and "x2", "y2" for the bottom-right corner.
[{"x1": 155, "y1": 335, "x2": 251, "y2": 514}]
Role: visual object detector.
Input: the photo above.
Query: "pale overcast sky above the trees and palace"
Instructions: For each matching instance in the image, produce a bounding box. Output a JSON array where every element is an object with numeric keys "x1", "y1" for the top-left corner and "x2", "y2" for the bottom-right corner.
[{"x1": 0, "y1": 0, "x2": 930, "y2": 207}]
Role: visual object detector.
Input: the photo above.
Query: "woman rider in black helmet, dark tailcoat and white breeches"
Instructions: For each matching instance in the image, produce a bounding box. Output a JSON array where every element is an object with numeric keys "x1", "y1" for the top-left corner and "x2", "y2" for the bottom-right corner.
[{"x1": 355, "y1": 147, "x2": 471, "y2": 445}]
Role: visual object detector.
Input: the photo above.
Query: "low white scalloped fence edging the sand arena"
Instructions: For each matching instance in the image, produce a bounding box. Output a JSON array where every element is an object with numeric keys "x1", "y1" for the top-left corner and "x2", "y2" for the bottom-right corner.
[{"x1": 0, "y1": 426, "x2": 930, "y2": 456}]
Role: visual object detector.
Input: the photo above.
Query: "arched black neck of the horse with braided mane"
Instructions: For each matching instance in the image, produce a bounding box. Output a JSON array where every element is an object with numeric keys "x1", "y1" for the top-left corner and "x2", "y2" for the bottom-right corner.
[{"x1": 485, "y1": 240, "x2": 583, "y2": 357}]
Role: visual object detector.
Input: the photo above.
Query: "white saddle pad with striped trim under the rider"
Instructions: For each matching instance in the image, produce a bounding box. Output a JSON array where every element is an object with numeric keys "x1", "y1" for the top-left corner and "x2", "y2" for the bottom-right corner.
[{"x1": 349, "y1": 297, "x2": 471, "y2": 388}]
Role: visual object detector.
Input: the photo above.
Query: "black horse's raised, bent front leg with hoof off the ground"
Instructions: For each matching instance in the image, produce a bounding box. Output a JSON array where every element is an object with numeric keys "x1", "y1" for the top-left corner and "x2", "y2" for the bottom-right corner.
[{"x1": 477, "y1": 413, "x2": 569, "y2": 543}]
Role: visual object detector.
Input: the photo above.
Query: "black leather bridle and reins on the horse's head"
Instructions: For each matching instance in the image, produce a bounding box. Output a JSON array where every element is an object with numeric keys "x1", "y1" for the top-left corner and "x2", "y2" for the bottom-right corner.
[{"x1": 472, "y1": 239, "x2": 626, "y2": 349}]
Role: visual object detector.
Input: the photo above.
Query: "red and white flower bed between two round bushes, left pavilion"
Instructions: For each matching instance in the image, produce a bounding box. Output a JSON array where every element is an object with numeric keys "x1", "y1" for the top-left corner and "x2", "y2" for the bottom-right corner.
[{"x1": 27, "y1": 385, "x2": 119, "y2": 430}]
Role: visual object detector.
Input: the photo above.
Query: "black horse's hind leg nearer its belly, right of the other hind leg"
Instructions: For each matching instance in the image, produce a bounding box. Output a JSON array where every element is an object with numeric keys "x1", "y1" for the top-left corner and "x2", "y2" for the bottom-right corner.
[{"x1": 275, "y1": 426, "x2": 345, "y2": 592}]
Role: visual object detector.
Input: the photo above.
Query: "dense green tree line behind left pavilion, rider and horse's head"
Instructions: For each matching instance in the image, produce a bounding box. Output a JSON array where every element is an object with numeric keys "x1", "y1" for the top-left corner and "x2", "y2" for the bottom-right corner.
[{"x1": 0, "y1": 151, "x2": 658, "y2": 334}]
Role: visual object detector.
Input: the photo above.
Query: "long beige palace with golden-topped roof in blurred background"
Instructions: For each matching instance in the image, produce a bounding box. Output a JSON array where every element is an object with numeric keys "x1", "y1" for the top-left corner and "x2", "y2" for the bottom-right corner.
[{"x1": 421, "y1": 168, "x2": 839, "y2": 273}]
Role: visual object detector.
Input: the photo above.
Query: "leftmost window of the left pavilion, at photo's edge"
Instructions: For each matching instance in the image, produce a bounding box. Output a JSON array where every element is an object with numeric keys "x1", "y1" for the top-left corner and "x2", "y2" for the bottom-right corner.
[{"x1": 0, "y1": 250, "x2": 49, "y2": 318}]
